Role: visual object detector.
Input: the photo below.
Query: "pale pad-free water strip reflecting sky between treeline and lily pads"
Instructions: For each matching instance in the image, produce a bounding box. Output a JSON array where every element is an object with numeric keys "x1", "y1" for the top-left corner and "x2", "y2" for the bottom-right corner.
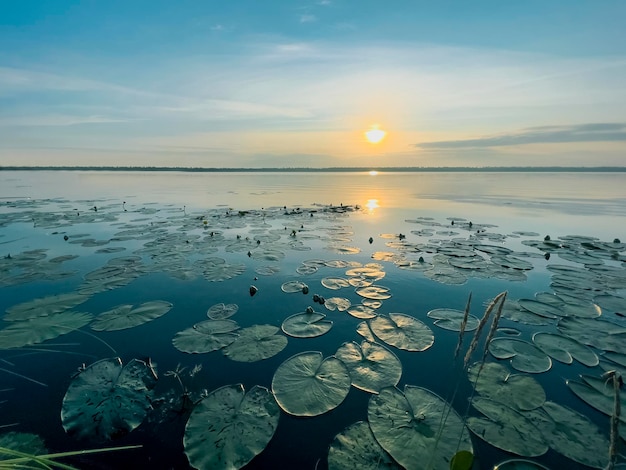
[{"x1": 0, "y1": 172, "x2": 626, "y2": 240}]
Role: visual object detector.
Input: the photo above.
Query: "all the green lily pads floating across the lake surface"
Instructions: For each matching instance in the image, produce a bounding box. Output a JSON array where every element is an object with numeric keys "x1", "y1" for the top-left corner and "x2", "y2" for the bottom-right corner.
[{"x1": 0, "y1": 196, "x2": 626, "y2": 469}]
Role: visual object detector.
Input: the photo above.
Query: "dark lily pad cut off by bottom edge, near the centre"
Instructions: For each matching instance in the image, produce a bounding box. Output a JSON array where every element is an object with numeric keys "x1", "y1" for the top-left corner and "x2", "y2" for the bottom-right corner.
[{"x1": 328, "y1": 421, "x2": 402, "y2": 470}]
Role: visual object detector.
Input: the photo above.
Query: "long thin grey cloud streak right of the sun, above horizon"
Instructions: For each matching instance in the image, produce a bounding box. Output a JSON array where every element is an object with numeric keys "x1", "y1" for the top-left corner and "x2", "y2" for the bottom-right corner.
[{"x1": 415, "y1": 123, "x2": 626, "y2": 149}]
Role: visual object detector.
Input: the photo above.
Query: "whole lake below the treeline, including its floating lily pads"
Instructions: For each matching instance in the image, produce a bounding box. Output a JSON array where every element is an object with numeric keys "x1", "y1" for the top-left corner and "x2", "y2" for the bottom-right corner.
[{"x1": 0, "y1": 171, "x2": 626, "y2": 469}]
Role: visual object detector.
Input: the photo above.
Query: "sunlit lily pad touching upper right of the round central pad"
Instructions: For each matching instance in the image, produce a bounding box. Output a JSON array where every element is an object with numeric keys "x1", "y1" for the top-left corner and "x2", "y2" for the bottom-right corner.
[{"x1": 335, "y1": 341, "x2": 402, "y2": 393}]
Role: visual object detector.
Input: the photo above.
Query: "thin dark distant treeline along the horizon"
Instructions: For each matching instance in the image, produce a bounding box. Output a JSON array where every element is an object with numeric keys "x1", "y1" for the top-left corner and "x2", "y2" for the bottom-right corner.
[{"x1": 0, "y1": 166, "x2": 626, "y2": 173}]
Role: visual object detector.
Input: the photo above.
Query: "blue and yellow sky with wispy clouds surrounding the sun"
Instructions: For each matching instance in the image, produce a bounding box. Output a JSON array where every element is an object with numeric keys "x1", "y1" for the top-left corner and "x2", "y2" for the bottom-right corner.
[{"x1": 0, "y1": 0, "x2": 626, "y2": 168}]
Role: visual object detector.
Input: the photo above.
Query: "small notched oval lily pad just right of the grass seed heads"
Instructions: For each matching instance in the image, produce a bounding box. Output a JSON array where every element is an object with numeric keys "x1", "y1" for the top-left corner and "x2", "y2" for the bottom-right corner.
[{"x1": 489, "y1": 338, "x2": 552, "y2": 374}]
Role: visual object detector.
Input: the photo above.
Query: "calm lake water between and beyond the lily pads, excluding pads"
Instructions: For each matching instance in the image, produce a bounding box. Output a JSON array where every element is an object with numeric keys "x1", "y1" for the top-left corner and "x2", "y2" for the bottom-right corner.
[{"x1": 0, "y1": 172, "x2": 626, "y2": 469}]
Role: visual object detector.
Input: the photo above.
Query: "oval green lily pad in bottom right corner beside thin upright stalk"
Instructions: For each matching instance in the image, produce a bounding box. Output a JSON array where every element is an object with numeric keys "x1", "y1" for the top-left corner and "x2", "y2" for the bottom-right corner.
[{"x1": 532, "y1": 401, "x2": 609, "y2": 468}]
